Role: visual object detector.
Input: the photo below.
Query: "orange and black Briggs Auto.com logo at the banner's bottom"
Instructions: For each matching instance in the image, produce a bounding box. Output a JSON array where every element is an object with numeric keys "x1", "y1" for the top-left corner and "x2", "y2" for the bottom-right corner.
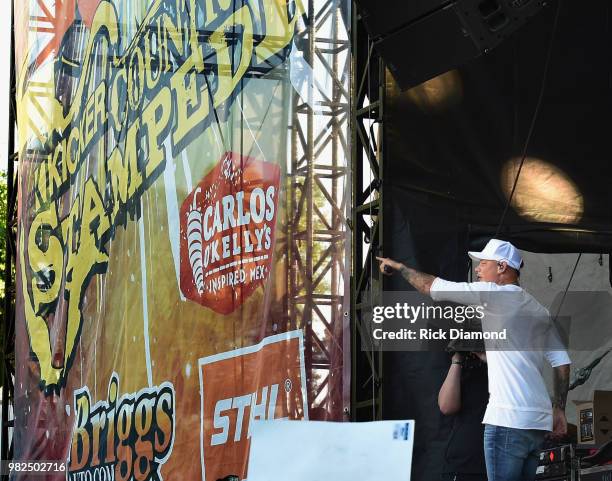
[{"x1": 67, "y1": 373, "x2": 176, "y2": 481}]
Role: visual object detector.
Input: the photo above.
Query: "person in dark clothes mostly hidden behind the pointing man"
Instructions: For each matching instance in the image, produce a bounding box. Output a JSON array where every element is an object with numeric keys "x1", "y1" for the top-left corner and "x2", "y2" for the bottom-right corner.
[{"x1": 438, "y1": 352, "x2": 489, "y2": 481}]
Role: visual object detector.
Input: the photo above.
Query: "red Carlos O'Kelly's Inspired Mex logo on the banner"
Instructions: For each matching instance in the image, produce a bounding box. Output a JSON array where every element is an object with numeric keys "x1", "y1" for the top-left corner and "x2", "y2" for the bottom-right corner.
[{"x1": 181, "y1": 152, "x2": 280, "y2": 314}]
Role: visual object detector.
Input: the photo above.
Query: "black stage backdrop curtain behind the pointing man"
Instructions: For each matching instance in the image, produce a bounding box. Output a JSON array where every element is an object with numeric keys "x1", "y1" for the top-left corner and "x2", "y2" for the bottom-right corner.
[{"x1": 383, "y1": 0, "x2": 612, "y2": 481}]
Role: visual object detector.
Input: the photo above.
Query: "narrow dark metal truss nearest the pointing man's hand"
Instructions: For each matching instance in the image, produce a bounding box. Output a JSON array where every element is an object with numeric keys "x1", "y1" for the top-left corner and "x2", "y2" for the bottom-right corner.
[{"x1": 351, "y1": 8, "x2": 385, "y2": 421}]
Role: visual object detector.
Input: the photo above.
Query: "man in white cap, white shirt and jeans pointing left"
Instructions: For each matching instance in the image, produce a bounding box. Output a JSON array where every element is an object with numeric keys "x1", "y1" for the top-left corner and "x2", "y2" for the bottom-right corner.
[{"x1": 378, "y1": 239, "x2": 570, "y2": 481}]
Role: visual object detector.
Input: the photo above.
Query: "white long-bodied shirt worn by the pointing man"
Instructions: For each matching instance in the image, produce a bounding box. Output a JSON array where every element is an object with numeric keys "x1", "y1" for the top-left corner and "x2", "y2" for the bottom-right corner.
[{"x1": 431, "y1": 278, "x2": 571, "y2": 431}]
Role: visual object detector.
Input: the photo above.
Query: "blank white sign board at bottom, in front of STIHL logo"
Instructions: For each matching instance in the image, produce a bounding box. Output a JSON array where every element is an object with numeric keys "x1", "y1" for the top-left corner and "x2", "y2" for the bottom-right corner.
[{"x1": 247, "y1": 421, "x2": 414, "y2": 481}]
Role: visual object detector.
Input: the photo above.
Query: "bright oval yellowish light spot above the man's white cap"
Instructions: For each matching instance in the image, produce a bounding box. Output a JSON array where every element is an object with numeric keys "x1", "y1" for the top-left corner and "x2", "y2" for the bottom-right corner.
[{"x1": 501, "y1": 157, "x2": 584, "y2": 224}]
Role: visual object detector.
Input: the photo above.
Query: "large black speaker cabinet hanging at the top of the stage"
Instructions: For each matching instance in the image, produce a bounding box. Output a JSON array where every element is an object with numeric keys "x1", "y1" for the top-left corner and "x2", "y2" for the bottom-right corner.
[{"x1": 356, "y1": 0, "x2": 547, "y2": 90}]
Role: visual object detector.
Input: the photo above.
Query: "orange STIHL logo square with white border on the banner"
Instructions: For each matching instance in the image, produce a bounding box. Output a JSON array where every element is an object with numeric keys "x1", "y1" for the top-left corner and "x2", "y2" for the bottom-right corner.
[{"x1": 198, "y1": 331, "x2": 308, "y2": 481}]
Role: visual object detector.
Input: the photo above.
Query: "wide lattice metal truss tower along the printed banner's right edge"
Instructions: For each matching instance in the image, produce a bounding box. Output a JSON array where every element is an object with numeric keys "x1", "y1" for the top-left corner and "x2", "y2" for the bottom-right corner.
[{"x1": 287, "y1": 0, "x2": 350, "y2": 419}]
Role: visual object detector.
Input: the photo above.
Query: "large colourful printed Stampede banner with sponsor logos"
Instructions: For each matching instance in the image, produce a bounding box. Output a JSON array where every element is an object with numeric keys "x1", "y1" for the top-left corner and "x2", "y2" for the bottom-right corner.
[{"x1": 15, "y1": 0, "x2": 342, "y2": 481}]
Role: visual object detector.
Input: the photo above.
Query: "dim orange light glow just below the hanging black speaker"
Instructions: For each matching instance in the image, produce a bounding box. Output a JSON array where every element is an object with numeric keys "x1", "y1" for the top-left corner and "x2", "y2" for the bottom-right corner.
[{"x1": 405, "y1": 70, "x2": 463, "y2": 111}]
